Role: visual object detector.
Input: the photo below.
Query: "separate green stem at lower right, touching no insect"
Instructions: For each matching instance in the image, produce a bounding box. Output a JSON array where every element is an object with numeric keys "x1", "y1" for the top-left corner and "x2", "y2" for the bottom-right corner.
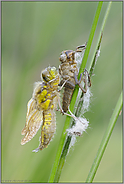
[{"x1": 86, "y1": 92, "x2": 123, "y2": 183}]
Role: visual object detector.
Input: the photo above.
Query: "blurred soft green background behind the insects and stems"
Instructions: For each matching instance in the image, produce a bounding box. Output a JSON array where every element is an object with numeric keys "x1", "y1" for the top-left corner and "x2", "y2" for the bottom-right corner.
[{"x1": 1, "y1": 2, "x2": 122, "y2": 183}]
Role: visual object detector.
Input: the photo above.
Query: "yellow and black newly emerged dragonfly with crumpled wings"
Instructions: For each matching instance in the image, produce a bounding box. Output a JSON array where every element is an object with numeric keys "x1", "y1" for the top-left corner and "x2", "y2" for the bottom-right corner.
[{"x1": 21, "y1": 67, "x2": 60, "y2": 152}]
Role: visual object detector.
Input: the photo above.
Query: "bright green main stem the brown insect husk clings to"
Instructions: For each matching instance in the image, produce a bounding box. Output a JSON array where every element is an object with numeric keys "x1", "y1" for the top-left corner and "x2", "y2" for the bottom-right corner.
[{"x1": 49, "y1": 2, "x2": 103, "y2": 182}]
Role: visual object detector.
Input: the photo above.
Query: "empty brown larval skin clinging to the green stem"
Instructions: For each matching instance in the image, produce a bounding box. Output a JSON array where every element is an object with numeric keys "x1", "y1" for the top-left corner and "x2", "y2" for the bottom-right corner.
[{"x1": 59, "y1": 44, "x2": 91, "y2": 114}]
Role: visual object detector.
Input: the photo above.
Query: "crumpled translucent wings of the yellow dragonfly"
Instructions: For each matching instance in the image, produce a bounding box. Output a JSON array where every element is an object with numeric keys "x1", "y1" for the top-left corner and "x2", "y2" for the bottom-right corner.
[{"x1": 21, "y1": 98, "x2": 43, "y2": 145}]
